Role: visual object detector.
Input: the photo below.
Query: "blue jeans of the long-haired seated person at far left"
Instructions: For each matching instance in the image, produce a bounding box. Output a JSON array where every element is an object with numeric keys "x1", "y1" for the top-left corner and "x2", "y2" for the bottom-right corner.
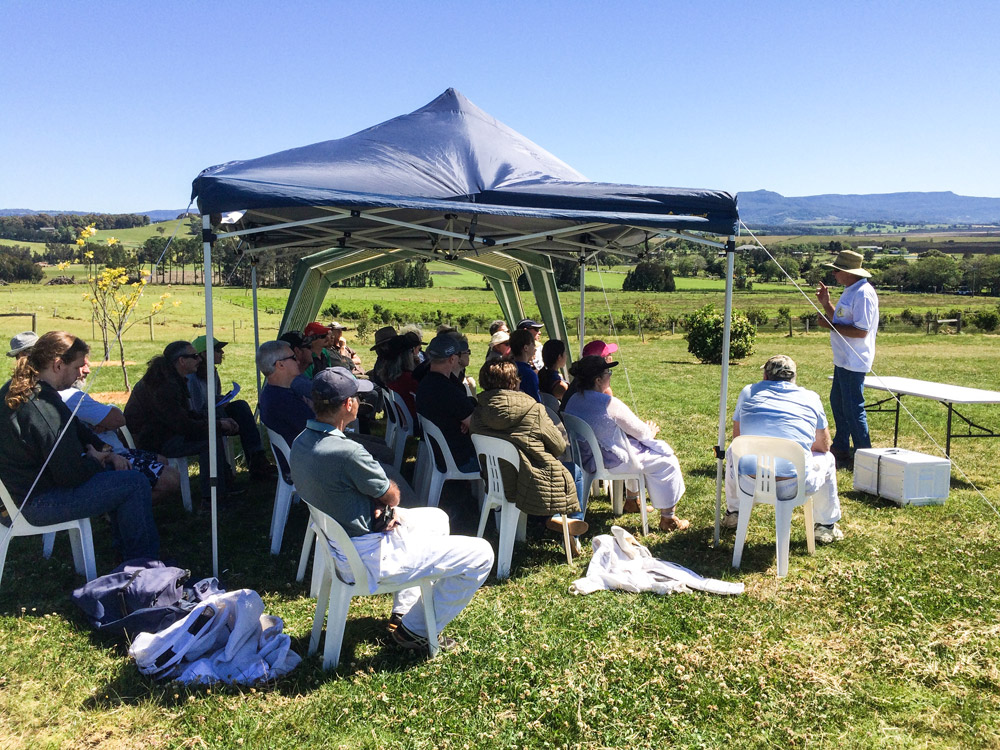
[{"x1": 24, "y1": 470, "x2": 160, "y2": 560}]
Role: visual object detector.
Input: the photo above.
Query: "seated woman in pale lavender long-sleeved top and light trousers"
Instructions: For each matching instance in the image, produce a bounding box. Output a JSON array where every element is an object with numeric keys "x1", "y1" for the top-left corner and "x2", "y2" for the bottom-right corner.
[{"x1": 564, "y1": 356, "x2": 690, "y2": 531}]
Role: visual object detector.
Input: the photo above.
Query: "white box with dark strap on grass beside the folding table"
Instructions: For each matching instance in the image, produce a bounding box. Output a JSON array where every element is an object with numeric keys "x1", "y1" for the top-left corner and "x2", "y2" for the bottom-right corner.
[{"x1": 854, "y1": 448, "x2": 951, "y2": 506}]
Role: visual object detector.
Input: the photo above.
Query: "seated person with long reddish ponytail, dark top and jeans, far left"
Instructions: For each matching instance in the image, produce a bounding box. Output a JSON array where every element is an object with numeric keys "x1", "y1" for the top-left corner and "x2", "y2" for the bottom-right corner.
[{"x1": 0, "y1": 331, "x2": 160, "y2": 560}]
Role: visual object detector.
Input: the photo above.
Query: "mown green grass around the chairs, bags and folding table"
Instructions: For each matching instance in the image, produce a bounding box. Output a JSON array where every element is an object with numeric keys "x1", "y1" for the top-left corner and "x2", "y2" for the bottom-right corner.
[{"x1": 0, "y1": 287, "x2": 1000, "y2": 748}]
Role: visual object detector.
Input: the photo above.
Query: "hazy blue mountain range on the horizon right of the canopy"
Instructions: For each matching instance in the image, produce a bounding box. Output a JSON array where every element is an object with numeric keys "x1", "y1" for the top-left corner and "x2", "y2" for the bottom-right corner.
[{"x1": 739, "y1": 190, "x2": 1000, "y2": 226}]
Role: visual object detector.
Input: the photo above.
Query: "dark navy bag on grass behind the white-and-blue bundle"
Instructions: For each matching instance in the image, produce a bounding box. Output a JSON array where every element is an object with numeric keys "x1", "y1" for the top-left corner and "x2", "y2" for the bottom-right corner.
[{"x1": 72, "y1": 558, "x2": 195, "y2": 640}]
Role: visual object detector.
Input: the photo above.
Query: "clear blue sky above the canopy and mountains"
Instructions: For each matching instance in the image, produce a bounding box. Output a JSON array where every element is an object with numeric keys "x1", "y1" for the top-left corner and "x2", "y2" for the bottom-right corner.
[{"x1": 0, "y1": 0, "x2": 1000, "y2": 212}]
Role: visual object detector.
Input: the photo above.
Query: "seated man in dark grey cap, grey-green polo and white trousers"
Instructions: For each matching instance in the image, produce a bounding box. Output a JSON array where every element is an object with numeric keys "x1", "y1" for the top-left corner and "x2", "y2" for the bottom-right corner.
[{"x1": 291, "y1": 367, "x2": 493, "y2": 651}]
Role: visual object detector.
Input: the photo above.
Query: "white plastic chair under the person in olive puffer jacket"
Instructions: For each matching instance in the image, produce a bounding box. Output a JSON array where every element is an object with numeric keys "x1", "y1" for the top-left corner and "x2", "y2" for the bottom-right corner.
[{"x1": 472, "y1": 435, "x2": 573, "y2": 580}]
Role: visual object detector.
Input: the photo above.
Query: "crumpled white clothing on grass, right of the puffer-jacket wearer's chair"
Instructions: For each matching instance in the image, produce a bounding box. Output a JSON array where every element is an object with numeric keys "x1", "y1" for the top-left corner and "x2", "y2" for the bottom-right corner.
[{"x1": 569, "y1": 526, "x2": 743, "y2": 596}]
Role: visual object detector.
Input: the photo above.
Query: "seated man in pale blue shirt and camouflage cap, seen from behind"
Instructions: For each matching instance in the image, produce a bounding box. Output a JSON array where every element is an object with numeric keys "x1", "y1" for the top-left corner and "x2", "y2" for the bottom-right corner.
[{"x1": 722, "y1": 354, "x2": 844, "y2": 544}]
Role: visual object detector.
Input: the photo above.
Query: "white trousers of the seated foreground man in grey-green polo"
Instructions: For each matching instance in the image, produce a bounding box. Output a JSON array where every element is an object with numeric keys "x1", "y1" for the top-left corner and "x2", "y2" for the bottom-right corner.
[{"x1": 359, "y1": 507, "x2": 493, "y2": 637}]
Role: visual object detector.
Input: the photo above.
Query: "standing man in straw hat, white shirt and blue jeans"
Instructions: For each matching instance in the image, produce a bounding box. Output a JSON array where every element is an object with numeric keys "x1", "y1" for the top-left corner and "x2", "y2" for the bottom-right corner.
[{"x1": 816, "y1": 250, "x2": 879, "y2": 466}]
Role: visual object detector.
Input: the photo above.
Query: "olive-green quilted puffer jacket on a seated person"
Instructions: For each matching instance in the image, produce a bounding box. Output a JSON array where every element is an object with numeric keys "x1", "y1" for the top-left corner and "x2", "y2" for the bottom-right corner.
[{"x1": 472, "y1": 390, "x2": 580, "y2": 516}]
